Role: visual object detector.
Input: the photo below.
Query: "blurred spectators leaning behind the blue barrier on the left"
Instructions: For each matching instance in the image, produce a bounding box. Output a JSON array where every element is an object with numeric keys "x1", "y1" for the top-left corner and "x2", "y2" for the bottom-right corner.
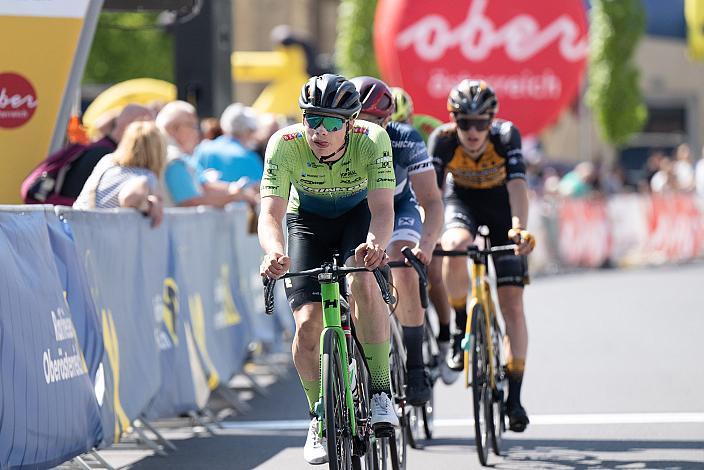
[{"x1": 23, "y1": 101, "x2": 287, "y2": 226}]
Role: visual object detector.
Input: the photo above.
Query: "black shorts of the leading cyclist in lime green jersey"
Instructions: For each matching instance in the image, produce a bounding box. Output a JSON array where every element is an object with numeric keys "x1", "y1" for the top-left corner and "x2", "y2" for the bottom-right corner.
[{"x1": 284, "y1": 199, "x2": 371, "y2": 310}]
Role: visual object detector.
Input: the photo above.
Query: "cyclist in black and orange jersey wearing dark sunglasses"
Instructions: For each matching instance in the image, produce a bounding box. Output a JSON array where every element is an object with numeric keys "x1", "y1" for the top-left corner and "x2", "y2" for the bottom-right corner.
[{"x1": 428, "y1": 79, "x2": 535, "y2": 432}]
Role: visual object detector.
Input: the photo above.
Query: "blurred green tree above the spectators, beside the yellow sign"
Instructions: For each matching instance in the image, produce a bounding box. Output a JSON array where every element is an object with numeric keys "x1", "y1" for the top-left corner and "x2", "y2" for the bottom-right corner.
[{"x1": 83, "y1": 12, "x2": 174, "y2": 84}]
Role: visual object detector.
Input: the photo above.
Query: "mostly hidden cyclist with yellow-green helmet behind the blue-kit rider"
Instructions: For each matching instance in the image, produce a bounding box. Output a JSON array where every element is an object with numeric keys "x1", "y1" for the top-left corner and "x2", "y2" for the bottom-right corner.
[{"x1": 384, "y1": 87, "x2": 459, "y2": 385}]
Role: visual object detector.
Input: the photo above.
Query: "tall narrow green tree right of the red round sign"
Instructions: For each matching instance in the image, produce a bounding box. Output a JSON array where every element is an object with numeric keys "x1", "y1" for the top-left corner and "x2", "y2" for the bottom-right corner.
[{"x1": 587, "y1": 0, "x2": 648, "y2": 145}]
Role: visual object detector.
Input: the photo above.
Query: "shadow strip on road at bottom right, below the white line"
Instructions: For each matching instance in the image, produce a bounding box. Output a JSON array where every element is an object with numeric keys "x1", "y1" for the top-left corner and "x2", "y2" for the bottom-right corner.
[{"x1": 422, "y1": 437, "x2": 704, "y2": 470}]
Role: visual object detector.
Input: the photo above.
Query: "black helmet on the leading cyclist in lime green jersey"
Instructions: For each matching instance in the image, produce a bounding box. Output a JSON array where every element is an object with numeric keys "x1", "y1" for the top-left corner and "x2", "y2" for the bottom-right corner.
[{"x1": 298, "y1": 73, "x2": 362, "y2": 119}]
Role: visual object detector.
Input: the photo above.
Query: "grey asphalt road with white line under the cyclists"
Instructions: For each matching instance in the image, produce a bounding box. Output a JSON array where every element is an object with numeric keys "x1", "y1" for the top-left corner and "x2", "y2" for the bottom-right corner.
[{"x1": 99, "y1": 264, "x2": 704, "y2": 470}]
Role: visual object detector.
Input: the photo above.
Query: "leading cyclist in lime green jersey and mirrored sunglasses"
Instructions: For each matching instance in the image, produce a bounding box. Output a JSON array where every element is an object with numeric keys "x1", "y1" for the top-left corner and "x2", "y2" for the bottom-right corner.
[{"x1": 259, "y1": 74, "x2": 398, "y2": 464}]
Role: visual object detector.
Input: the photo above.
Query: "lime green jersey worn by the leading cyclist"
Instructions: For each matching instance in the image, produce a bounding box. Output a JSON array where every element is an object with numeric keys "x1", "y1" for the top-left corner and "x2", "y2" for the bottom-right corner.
[{"x1": 261, "y1": 120, "x2": 396, "y2": 218}]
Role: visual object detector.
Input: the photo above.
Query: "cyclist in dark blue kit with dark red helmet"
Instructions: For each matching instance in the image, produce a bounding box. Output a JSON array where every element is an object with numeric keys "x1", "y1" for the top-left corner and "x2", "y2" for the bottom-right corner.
[{"x1": 351, "y1": 77, "x2": 443, "y2": 405}]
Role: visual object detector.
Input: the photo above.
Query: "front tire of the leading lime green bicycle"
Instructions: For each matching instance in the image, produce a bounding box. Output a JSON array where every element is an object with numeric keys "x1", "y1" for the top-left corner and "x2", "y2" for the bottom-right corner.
[{"x1": 321, "y1": 330, "x2": 352, "y2": 470}]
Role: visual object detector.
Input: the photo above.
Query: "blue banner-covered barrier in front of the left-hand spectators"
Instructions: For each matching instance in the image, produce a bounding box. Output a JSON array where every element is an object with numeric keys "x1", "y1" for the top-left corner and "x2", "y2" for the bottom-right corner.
[{"x1": 0, "y1": 206, "x2": 261, "y2": 469}]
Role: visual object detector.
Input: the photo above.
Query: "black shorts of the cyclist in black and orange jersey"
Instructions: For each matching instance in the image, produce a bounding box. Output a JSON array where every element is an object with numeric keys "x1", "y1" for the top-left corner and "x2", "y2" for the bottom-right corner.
[{"x1": 445, "y1": 188, "x2": 530, "y2": 287}]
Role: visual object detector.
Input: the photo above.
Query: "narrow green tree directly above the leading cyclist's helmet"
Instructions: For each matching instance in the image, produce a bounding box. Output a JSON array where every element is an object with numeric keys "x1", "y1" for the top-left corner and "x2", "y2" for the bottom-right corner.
[{"x1": 335, "y1": 0, "x2": 381, "y2": 77}]
